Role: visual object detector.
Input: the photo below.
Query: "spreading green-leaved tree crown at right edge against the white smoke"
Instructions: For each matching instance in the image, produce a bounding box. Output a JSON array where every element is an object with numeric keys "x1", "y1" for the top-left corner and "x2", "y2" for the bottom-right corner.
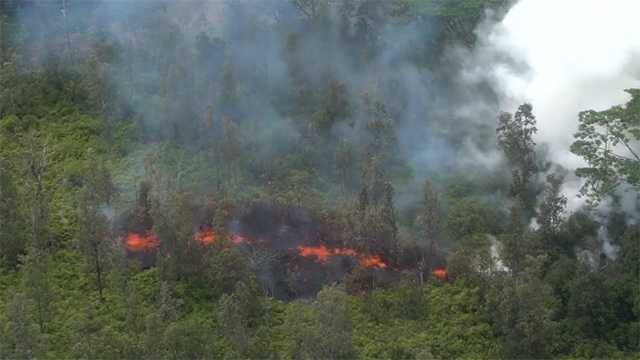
[{"x1": 571, "y1": 89, "x2": 640, "y2": 202}]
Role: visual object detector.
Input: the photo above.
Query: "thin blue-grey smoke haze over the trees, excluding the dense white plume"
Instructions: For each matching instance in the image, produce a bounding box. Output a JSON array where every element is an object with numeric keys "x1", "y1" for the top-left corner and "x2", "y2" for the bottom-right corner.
[{"x1": 5, "y1": 0, "x2": 510, "y2": 209}]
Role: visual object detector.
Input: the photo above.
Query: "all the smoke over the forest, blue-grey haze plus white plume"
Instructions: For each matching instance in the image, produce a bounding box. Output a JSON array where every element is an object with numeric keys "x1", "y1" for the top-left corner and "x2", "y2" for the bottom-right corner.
[{"x1": 15, "y1": 0, "x2": 640, "y2": 228}]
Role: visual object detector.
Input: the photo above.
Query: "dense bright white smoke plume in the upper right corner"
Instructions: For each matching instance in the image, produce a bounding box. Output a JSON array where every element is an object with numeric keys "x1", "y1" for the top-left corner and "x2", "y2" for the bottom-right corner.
[{"x1": 465, "y1": 0, "x2": 640, "y2": 208}]
